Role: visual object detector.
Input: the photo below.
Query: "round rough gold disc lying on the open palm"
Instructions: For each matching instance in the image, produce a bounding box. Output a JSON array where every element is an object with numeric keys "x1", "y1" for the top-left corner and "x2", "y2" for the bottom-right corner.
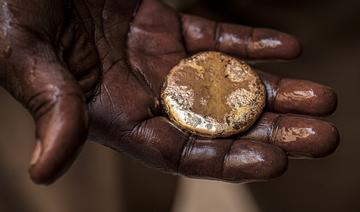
[{"x1": 161, "y1": 52, "x2": 266, "y2": 138}]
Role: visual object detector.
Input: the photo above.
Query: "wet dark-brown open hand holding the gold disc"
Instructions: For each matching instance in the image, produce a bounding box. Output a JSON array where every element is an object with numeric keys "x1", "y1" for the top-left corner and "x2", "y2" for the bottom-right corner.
[{"x1": 0, "y1": 0, "x2": 339, "y2": 183}]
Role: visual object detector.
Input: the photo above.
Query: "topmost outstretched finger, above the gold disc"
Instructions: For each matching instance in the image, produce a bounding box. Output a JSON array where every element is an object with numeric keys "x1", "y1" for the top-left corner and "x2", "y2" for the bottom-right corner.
[{"x1": 182, "y1": 15, "x2": 301, "y2": 59}]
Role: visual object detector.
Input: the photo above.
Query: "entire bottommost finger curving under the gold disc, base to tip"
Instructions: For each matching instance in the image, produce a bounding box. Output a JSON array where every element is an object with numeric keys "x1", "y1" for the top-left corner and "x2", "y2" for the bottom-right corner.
[{"x1": 117, "y1": 117, "x2": 287, "y2": 182}]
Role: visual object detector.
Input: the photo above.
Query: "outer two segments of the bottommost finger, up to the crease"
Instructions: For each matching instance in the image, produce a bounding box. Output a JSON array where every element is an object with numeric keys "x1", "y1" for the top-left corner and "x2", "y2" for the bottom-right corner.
[{"x1": 179, "y1": 137, "x2": 287, "y2": 182}]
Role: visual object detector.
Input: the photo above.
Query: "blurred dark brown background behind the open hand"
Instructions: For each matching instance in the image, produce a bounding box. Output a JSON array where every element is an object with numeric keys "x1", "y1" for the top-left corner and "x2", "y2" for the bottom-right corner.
[{"x1": 0, "y1": 0, "x2": 360, "y2": 212}]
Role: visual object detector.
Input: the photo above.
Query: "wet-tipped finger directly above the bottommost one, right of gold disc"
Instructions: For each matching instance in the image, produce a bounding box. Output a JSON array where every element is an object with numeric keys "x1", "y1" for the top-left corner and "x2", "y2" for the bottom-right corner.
[{"x1": 243, "y1": 113, "x2": 339, "y2": 157}]
